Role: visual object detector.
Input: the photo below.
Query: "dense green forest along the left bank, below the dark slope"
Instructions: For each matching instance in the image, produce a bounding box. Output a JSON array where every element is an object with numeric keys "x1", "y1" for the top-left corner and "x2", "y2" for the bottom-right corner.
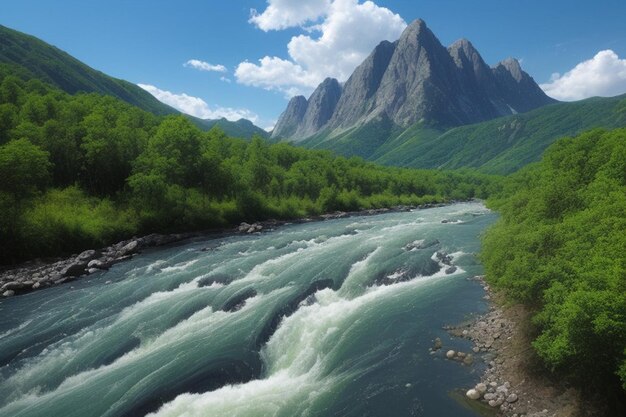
[{"x1": 0, "y1": 66, "x2": 498, "y2": 264}]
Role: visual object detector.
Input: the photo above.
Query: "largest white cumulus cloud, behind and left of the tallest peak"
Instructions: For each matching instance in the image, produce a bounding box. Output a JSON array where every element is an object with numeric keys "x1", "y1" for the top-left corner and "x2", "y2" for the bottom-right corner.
[{"x1": 235, "y1": 0, "x2": 406, "y2": 97}]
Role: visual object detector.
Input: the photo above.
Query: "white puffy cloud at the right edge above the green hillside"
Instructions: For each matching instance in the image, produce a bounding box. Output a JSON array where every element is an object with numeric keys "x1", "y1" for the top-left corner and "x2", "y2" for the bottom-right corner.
[{"x1": 540, "y1": 50, "x2": 626, "y2": 101}]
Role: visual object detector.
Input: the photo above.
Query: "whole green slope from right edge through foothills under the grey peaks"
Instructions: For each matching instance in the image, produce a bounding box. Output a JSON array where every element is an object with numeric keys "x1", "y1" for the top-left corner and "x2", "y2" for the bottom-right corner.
[{"x1": 301, "y1": 95, "x2": 626, "y2": 174}]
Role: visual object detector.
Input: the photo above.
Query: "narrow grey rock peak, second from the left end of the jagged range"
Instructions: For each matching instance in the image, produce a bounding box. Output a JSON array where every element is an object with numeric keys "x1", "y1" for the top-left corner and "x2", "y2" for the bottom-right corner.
[{"x1": 295, "y1": 78, "x2": 341, "y2": 138}]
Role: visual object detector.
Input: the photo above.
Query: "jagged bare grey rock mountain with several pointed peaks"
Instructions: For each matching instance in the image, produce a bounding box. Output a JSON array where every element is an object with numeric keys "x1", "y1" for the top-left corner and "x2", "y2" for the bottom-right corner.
[{"x1": 272, "y1": 20, "x2": 555, "y2": 141}]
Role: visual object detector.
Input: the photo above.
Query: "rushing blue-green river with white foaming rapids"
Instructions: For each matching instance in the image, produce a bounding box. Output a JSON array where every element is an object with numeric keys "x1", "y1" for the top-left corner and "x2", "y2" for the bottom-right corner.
[{"x1": 0, "y1": 203, "x2": 495, "y2": 417}]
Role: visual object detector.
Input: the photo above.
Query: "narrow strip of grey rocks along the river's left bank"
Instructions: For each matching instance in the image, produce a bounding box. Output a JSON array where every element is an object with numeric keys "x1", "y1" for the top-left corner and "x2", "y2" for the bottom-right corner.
[{"x1": 0, "y1": 204, "x2": 445, "y2": 297}]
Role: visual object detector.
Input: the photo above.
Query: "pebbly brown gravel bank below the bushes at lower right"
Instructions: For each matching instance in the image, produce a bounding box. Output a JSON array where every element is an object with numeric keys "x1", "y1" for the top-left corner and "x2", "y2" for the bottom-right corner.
[{"x1": 442, "y1": 277, "x2": 584, "y2": 417}]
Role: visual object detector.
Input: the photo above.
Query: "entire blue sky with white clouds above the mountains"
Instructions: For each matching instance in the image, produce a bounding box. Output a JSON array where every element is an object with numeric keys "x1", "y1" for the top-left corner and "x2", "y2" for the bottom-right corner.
[{"x1": 0, "y1": 0, "x2": 626, "y2": 129}]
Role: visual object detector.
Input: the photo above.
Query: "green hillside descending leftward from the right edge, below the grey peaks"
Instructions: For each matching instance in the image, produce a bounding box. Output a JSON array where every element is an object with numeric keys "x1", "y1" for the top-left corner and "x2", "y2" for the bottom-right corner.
[{"x1": 386, "y1": 95, "x2": 626, "y2": 174}]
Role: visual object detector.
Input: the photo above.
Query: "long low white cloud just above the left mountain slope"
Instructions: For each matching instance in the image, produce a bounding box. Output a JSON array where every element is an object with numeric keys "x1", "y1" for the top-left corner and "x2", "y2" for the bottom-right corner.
[{"x1": 137, "y1": 84, "x2": 259, "y2": 123}]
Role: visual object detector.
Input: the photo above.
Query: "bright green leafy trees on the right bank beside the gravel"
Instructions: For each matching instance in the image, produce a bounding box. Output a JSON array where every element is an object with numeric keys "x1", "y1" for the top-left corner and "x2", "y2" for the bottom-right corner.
[{"x1": 482, "y1": 129, "x2": 626, "y2": 398}]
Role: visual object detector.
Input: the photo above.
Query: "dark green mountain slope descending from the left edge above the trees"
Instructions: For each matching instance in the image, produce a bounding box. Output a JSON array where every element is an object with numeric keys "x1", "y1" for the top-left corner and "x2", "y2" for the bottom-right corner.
[{"x1": 0, "y1": 25, "x2": 178, "y2": 115}]
